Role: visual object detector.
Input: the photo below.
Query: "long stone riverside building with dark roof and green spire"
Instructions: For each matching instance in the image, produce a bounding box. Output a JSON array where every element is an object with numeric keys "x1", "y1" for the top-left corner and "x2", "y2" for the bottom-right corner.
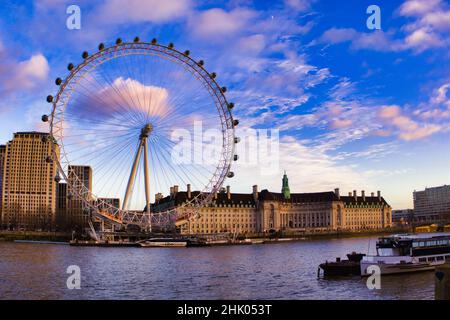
[{"x1": 152, "y1": 174, "x2": 392, "y2": 234}]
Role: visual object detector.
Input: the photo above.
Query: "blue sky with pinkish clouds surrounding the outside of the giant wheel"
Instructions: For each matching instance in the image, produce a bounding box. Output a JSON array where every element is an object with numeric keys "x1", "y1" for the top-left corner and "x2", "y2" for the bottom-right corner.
[{"x1": 0, "y1": 0, "x2": 450, "y2": 208}]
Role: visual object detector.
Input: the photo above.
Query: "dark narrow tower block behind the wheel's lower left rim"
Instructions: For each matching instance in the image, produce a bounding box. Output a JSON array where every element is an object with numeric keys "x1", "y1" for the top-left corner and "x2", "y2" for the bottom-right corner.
[{"x1": 67, "y1": 166, "x2": 92, "y2": 228}]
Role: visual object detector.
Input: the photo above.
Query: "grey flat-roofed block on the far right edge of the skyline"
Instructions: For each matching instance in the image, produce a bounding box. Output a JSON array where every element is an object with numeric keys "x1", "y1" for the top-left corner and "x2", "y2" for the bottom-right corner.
[{"x1": 413, "y1": 185, "x2": 450, "y2": 222}]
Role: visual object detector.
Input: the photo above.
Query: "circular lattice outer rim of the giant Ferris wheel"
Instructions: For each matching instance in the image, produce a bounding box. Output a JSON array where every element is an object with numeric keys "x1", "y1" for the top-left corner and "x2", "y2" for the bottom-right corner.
[{"x1": 50, "y1": 42, "x2": 235, "y2": 225}]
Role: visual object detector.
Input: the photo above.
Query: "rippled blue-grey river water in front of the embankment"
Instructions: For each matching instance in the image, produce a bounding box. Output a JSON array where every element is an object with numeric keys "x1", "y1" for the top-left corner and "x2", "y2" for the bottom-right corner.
[{"x1": 0, "y1": 237, "x2": 434, "y2": 300}]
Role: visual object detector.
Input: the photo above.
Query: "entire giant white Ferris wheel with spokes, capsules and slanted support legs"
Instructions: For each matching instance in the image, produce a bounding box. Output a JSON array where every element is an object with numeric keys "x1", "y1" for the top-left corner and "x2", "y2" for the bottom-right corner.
[{"x1": 42, "y1": 37, "x2": 239, "y2": 230}]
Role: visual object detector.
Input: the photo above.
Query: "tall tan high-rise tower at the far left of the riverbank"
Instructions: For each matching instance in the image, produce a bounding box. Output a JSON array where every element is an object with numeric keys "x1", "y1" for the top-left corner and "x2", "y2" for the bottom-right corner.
[{"x1": 2, "y1": 132, "x2": 59, "y2": 230}]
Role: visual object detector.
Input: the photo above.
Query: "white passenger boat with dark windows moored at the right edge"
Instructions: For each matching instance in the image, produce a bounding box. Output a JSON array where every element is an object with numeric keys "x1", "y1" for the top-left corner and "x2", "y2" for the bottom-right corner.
[{"x1": 360, "y1": 233, "x2": 450, "y2": 276}]
